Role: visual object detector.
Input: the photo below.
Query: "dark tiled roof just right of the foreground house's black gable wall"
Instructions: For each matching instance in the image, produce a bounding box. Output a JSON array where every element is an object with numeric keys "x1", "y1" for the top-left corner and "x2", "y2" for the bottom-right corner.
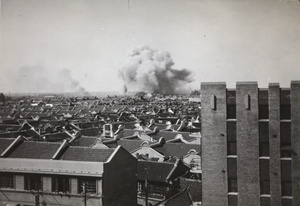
[{"x1": 137, "y1": 160, "x2": 174, "y2": 182}]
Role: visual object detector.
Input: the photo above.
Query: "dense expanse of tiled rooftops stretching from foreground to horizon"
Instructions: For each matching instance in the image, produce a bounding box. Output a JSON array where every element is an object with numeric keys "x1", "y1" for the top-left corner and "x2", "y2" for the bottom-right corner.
[{"x1": 0, "y1": 92, "x2": 201, "y2": 205}]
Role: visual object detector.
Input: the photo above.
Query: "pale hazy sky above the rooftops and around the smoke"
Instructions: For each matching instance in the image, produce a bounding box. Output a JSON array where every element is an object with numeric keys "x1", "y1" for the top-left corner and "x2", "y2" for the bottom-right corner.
[{"x1": 0, "y1": 0, "x2": 300, "y2": 92}]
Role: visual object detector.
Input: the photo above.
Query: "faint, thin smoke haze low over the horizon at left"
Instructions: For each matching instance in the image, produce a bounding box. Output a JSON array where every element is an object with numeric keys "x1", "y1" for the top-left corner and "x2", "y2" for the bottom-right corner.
[{"x1": 15, "y1": 66, "x2": 88, "y2": 95}]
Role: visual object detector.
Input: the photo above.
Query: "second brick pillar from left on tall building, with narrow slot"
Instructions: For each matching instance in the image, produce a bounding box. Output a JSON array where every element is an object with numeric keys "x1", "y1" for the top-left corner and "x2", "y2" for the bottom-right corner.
[{"x1": 236, "y1": 82, "x2": 260, "y2": 206}]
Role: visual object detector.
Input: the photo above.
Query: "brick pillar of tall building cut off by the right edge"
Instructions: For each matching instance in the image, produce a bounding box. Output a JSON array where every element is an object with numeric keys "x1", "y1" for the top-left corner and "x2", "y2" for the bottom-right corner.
[{"x1": 291, "y1": 81, "x2": 300, "y2": 206}]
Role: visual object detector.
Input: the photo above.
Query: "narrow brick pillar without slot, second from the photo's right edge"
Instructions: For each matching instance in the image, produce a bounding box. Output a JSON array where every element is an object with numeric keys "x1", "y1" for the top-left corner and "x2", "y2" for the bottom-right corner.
[{"x1": 269, "y1": 83, "x2": 281, "y2": 206}]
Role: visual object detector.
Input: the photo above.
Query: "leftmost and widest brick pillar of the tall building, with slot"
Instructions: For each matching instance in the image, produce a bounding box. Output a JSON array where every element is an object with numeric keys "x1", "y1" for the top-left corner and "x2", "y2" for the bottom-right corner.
[{"x1": 201, "y1": 83, "x2": 228, "y2": 206}]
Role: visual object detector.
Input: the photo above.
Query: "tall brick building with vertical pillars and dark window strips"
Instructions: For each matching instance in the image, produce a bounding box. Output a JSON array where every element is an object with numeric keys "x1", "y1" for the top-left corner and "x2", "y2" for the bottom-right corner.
[{"x1": 201, "y1": 81, "x2": 300, "y2": 206}]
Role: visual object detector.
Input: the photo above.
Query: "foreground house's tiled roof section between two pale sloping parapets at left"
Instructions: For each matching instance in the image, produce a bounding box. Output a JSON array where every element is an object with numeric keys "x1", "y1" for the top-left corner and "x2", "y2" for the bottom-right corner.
[{"x1": 8, "y1": 141, "x2": 60, "y2": 159}]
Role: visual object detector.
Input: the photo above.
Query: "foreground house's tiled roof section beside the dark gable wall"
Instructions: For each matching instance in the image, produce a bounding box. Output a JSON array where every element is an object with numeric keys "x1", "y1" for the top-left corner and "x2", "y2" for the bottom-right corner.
[{"x1": 61, "y1": 146, "x2": 114, "y2": 162}]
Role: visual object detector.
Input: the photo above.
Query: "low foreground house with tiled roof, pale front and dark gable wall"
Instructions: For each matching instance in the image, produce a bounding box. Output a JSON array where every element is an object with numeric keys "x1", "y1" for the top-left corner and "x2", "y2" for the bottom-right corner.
[{"x1": 0, "y1": 137, "x2": 137, "y2": 206}]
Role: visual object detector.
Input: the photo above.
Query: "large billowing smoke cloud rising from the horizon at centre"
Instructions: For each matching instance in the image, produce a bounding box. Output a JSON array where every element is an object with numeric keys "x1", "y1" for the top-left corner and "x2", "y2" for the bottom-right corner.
[{"x1": 119, "y1": 46, "x2": 194, "y2": 94}]
